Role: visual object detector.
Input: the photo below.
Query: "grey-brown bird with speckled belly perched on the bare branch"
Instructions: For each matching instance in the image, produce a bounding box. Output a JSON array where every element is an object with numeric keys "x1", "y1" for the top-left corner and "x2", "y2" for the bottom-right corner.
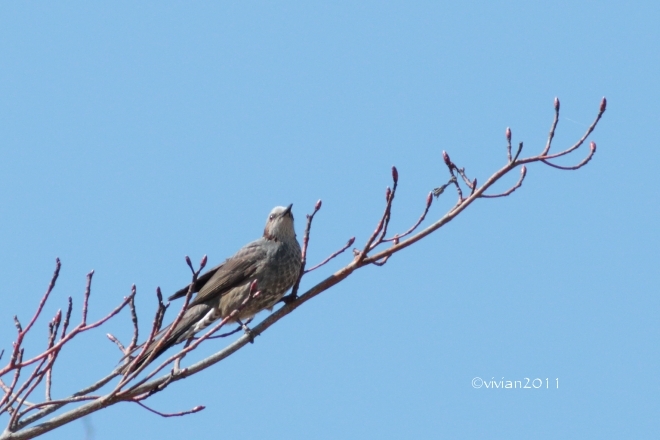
[{"x1": 124, "y1": 204, "x2": 302, "y2": 367}]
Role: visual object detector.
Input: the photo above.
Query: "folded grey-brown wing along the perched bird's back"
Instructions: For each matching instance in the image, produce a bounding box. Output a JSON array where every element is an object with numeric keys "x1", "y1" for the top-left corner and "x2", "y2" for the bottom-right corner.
[{"x1": 172, "y1": 240, "x2": 266, "y2": 307}]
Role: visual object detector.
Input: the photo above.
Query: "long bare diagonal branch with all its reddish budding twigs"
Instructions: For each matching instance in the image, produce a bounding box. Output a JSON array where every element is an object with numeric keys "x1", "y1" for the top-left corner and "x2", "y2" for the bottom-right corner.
[{"x1": 0, "y1": 99, "x2": 606, "y2": 440}]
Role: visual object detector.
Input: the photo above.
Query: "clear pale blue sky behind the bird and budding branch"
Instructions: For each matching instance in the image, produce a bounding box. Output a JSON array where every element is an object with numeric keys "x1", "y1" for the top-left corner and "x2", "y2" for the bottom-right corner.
[{"x1": 0, "y1": 1, "x2": 660, "y2": 440}]
